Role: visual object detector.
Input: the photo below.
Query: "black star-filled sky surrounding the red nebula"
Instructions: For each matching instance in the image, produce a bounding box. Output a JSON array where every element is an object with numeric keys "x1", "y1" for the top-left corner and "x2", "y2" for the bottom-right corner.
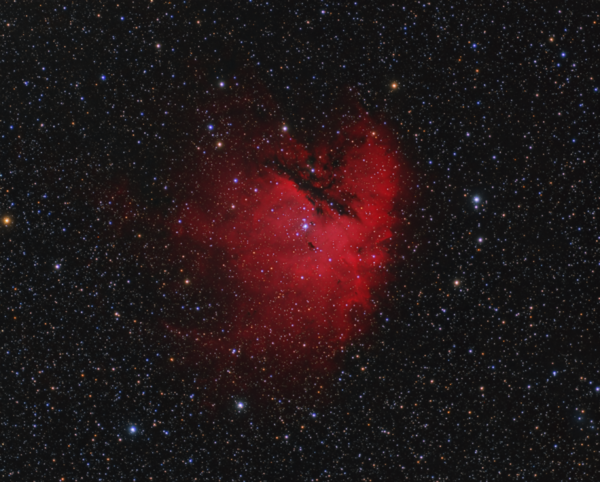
[{"x1": 0, "y1": 0, "x2": 600, "y2": 481}]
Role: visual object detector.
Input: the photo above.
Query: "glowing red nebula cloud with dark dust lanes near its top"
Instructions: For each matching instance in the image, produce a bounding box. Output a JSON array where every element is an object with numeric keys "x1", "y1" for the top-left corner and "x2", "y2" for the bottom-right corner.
[{"x1": 169, "y1": 86, "x2": 402, "y2": 396}]
